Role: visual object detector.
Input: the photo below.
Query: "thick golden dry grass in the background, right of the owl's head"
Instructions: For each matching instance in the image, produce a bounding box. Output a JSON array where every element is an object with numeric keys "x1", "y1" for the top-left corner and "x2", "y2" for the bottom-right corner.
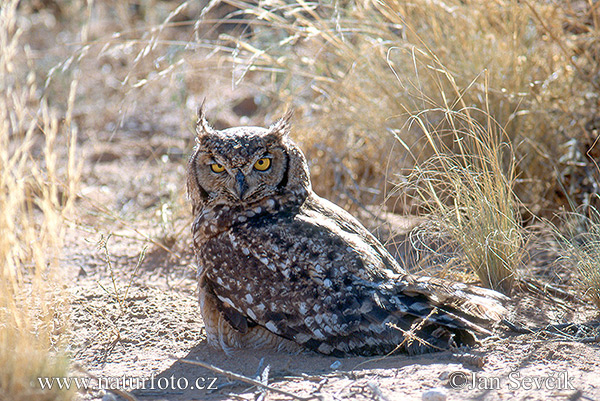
[{"x1": 204, "y1": 0, "x2": 600, "y2": 215}]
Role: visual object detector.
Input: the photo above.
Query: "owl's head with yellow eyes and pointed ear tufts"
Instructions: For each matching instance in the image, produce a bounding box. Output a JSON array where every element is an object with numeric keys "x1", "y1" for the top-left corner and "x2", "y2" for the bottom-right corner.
[{"x1": 187, "y1": 107, "x2": 310, "y2": 209}]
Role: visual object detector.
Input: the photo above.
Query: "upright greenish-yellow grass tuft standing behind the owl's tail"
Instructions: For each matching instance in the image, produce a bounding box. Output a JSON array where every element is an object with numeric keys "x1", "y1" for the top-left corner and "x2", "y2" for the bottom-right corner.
[{"x1": 400, "y1": 104, "x2": 524, "y2": 294}]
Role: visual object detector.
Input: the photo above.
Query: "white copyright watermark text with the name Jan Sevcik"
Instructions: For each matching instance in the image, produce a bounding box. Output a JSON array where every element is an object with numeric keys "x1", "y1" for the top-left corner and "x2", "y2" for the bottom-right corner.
[{"x1": 448, "y1": 370, "x2": 576, "y2": 390}]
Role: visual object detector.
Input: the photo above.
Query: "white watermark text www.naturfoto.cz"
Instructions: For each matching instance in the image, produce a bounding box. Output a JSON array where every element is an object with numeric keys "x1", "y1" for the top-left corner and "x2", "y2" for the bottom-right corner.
[{"x1": 37, "y1": 375, "x2": 217, "y2": 390}]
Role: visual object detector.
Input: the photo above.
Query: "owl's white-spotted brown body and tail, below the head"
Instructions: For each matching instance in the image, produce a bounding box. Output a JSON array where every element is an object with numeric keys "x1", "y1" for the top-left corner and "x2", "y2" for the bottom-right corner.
[{"x1": 194, "y1": 194, "x2": 505, "y2": 355}]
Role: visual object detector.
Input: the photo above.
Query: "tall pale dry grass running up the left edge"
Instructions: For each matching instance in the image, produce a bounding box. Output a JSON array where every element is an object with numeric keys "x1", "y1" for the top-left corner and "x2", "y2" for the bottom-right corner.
[{"x1": 0, "y1": 0, "x2": 77, "y2": 400}]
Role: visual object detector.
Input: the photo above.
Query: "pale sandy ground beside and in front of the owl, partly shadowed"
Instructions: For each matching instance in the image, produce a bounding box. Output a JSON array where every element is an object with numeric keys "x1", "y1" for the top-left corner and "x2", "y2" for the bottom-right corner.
[{"x1": 64, "y1": 222, "x2": 600, "y2": 400}]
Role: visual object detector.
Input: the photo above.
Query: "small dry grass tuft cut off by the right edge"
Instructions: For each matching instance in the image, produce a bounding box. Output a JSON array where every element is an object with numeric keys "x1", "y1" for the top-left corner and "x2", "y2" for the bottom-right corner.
[{"x1": 555, "y1": 208, "x2": 600, "y2": 308}]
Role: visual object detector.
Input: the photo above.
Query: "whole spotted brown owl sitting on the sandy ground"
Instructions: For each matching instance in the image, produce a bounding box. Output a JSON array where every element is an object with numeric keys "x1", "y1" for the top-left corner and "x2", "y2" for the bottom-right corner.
[{"x1": 187, "y1": 107, "x2": 505, "y2": 356}]
